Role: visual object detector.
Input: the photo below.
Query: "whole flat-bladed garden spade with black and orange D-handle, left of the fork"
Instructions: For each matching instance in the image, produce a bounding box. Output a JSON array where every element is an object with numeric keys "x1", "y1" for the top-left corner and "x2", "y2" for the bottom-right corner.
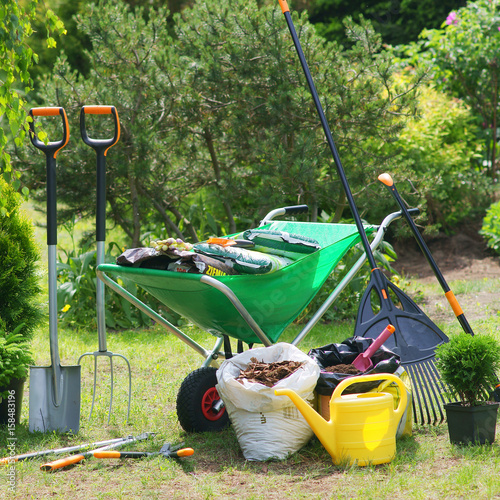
[{"x1": 29, "y1": 107, "x2": 81, "y2": 433}]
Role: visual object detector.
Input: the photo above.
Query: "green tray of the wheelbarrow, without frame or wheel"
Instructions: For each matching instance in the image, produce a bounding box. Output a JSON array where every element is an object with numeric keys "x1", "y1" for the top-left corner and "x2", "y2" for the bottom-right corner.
[{"x1": 98, "y1": 221, "x2": 374, "y2": 343}]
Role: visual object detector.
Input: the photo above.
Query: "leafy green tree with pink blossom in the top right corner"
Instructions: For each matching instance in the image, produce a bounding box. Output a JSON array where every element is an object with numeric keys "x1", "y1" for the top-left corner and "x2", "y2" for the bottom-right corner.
[{"x1": 398, "y1": 0, "x2": 500, "y2": 178}]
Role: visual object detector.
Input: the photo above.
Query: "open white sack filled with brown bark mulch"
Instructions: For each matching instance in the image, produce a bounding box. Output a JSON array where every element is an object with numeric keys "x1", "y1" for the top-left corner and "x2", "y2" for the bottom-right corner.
[{"x1": 216, "y1": 343, "x2": 320, "y2": 461}]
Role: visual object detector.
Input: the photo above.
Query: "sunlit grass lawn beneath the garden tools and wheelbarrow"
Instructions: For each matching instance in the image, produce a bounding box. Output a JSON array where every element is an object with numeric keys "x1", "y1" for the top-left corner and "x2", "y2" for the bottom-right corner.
[{"x1": 0, "y1": 202, "x2": 500, "y2": 500}]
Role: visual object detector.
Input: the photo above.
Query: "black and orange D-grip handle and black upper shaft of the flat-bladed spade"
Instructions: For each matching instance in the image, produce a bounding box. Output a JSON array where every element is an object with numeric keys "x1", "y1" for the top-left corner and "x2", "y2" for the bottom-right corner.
[{"x1": 28, "y1": 107, "x2": 69, "y2": 245}]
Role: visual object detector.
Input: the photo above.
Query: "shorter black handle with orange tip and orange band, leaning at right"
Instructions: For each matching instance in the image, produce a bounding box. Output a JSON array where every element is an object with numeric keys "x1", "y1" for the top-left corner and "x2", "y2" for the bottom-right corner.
[{"x1": 378, "y1": 174, "x2": 474, "y2": 335}]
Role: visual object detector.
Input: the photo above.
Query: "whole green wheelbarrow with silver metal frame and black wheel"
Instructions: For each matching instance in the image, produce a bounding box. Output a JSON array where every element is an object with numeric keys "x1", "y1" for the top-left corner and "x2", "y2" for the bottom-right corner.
[{"x1": 97, "y1": 205, "x2": 401, "y2": 432}]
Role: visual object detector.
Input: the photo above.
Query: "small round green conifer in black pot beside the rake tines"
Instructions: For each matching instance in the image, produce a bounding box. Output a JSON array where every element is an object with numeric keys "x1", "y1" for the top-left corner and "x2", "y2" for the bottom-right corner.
[{"x1": 436, "y1": 333, "x2": 500, "y2": 444}]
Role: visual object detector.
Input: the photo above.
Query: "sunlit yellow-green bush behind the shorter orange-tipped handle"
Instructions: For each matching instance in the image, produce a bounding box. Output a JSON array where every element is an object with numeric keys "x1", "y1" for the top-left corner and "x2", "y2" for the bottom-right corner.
[{"x1": 380, "y1": 80, "x2": 491, "y2": 233}]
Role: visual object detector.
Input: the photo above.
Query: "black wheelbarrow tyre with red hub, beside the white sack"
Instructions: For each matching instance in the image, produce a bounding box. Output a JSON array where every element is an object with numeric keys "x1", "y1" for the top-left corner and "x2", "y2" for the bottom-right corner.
[{"x1": 177, "y1": 366, "x2": 229, "y2": 432}]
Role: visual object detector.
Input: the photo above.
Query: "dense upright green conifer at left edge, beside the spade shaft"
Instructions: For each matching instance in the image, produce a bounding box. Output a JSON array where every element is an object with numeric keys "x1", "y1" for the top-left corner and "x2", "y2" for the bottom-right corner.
[{"x1": 0, "y1": 178, "x2": 43, "y2": 339}]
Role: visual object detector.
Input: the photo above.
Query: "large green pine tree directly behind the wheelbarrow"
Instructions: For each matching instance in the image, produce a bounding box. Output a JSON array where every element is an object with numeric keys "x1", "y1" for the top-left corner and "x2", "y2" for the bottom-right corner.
[{"x1": 20, "y1": 0, "x2": 421, "y2": 245}]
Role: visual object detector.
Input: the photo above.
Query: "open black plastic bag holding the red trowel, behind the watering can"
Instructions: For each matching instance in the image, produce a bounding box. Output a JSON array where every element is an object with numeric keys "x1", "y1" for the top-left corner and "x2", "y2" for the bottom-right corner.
[{"x1": 308, "y1": 336, "x2": 401, "y2": 396}]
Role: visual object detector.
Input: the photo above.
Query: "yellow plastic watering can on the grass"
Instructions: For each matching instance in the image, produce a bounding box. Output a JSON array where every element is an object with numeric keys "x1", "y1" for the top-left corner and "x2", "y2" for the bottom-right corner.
[{"x1": 274, "y1": 373, "x2": 408, "y2": 465}]
